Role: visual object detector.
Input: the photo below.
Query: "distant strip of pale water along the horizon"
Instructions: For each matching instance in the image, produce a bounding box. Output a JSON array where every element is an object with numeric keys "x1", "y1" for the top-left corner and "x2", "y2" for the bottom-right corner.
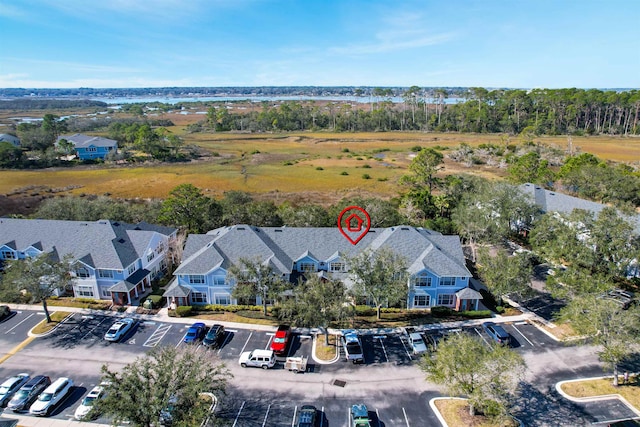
[{"x1": 89, "y1": 95, "x2": 465, "y2": 105}]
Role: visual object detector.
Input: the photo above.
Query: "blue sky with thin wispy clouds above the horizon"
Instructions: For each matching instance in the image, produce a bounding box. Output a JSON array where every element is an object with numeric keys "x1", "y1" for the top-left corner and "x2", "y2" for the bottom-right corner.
[{"x1": 0, "y1": 0, "x2": 640, "y2": 88}]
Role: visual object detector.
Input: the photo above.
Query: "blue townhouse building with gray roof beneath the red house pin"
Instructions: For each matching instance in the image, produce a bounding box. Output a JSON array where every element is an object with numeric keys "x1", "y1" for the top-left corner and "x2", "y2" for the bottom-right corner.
[{"x1": 164, "y1": 225, "x2": 481, "y2": 310}]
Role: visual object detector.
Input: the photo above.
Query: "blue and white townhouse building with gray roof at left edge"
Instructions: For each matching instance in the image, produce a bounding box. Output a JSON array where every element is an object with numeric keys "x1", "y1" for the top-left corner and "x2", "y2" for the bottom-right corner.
[{"x1": 0, "y1": 218, "x2": 177, "y2": 305}]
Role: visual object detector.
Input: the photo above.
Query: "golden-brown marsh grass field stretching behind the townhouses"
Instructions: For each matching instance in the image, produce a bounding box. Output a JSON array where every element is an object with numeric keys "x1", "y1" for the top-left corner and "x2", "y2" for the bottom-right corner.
[{"x1": 0, "y1": 116, "x2": 640, "y2": 204}]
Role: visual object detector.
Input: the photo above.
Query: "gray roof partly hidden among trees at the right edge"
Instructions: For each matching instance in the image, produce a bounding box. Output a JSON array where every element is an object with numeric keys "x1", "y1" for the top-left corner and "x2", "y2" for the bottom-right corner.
[{"x1": 518, "y1": 183, "x2": 640, "y2": 234}]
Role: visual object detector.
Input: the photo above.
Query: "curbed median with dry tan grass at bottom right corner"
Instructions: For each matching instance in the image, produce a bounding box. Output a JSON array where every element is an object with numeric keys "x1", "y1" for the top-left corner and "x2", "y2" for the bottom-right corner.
[{"x1": 556, "y1": 373, "x2": 640, "y2": 417}]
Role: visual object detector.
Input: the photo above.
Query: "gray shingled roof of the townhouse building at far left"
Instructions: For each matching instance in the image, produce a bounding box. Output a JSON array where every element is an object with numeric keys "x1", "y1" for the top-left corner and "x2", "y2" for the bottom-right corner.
[{"x1": 0, "y1": 218, "x2": 175, "y2": 270}]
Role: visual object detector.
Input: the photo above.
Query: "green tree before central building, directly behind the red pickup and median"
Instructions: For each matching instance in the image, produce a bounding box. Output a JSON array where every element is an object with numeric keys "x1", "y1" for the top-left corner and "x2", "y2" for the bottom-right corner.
[{"x1": 280, "y1": 275, "x2": 351, "y2": 342}]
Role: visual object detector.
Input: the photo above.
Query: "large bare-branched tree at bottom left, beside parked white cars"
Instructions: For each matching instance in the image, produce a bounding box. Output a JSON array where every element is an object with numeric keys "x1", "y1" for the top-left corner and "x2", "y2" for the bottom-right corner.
[{"x1": 95, "y1": 346, "x2": 231, "y2": 427}]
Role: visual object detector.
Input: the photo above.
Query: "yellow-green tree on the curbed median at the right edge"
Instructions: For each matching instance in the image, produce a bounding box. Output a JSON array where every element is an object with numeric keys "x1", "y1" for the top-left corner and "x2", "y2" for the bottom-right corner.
[{"x1": 559, "y1": 294, "x2": 640, "y2": 386}]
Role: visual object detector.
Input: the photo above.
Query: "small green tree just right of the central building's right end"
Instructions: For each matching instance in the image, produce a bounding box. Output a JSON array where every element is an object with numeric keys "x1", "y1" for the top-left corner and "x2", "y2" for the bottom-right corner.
[{"x1": 478, "y1": 249, "x2": 533, "y2": 298}]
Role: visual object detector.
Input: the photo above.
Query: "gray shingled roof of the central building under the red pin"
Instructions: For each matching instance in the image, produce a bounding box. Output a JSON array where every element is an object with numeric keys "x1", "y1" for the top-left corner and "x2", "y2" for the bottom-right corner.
[{"x1": 174, "y1": 225, "x2": 471, "y2": 277}]
